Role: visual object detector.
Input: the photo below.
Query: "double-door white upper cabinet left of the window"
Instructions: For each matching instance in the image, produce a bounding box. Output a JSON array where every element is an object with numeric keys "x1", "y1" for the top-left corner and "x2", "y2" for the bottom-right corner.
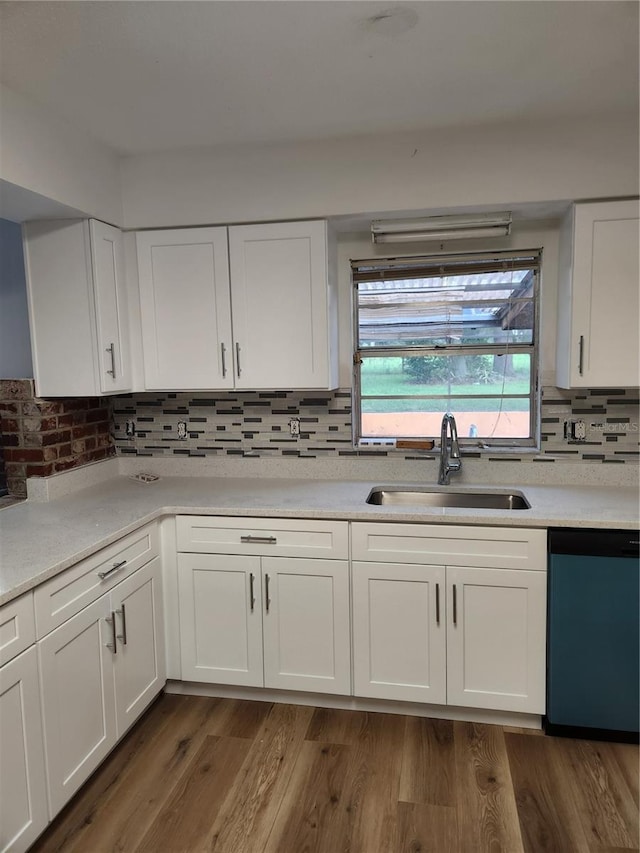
[{"x1": 136, "y1": 221, "x2": 337, "y2": 390}]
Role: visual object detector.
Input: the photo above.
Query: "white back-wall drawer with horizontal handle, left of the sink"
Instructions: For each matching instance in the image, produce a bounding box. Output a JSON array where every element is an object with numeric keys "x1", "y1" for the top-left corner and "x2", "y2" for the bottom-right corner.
[{"x1": 176, "y1": 515, "x2": 349, "y2": 560}]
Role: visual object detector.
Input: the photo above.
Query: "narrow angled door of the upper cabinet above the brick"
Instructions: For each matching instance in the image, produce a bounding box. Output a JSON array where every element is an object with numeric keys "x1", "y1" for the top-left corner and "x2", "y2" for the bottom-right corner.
[{"x1": 89, "y1": 219, "x2": 132, "y2": 394}]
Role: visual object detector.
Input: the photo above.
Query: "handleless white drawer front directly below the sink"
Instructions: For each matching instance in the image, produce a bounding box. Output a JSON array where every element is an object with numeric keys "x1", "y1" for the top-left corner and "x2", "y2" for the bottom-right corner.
[{"x1": 351, "y1": 522, "x2": 547, "y2": 571}]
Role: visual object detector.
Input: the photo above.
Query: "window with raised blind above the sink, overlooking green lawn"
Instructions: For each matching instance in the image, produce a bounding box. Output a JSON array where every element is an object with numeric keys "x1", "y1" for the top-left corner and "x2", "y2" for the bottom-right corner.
[{"x1": 351, "y1": 249, "x2": 541, "y2": 446}]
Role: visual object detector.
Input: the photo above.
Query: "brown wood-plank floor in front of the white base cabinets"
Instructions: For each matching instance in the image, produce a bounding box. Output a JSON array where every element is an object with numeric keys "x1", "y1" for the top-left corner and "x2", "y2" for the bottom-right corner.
[{"x1": 33, "y1": 695, "x2": 638, "y2": 853}]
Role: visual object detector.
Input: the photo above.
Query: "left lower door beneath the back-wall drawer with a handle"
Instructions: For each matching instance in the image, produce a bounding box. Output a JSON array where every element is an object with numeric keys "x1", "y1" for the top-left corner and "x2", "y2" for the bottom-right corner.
[{"x1": 178, "y1": 554, "x2": 263, "y2": 687}]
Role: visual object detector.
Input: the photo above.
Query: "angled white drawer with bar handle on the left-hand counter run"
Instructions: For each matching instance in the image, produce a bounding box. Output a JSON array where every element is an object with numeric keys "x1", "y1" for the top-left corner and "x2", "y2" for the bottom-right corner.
[{"x1": 34, "y1": 524, "x2": 160, "y2": 639}]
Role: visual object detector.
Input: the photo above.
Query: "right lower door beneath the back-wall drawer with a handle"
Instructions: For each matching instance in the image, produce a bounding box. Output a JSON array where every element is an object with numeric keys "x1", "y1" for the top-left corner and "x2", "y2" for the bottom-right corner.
[{"x1": 262, "y1": 557, "x2": 351, "y2": 695}]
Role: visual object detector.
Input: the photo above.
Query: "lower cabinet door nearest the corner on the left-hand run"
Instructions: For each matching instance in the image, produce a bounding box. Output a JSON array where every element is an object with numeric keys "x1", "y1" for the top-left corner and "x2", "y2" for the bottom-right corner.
[{"x1": 111, "y1": 557, "x2": 165, "y2": 737}]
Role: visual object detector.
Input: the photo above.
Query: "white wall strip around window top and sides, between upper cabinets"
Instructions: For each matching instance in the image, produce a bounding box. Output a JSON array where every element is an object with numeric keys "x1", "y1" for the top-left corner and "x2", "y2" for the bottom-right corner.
[{"x1": 338, "y1": 221, "x2": 560, "y2": 388}]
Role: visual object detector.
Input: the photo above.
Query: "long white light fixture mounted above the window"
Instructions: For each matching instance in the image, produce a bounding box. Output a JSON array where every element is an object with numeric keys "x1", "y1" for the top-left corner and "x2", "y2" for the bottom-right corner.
[{"x1": 371, "y1": 211, "x2": 511, "y2": 243}]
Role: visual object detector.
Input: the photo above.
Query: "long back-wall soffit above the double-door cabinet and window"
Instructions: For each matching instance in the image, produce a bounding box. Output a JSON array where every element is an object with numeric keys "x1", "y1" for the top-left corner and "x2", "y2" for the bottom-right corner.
[{"x1": 122, "y1": 116, "x2": 638, "y2": 228}]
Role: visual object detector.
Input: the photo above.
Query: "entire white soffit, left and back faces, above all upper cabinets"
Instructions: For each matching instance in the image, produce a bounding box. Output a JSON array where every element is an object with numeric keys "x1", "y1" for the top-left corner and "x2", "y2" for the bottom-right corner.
[{"x1": 0, "y1": 87, "x2": 639, "y2": 233}]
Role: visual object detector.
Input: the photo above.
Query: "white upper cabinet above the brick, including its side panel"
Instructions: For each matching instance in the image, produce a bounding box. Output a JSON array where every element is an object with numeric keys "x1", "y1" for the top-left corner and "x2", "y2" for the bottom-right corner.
[{"x1": 24, "y1": 219, "x2": 131, "y2": 397}]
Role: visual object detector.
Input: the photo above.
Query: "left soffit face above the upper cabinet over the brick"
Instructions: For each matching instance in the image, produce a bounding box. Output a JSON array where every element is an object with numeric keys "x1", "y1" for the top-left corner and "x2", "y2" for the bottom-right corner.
[{"x1": 0, "y1": 87, "x2": 122, "y2": 225}]
